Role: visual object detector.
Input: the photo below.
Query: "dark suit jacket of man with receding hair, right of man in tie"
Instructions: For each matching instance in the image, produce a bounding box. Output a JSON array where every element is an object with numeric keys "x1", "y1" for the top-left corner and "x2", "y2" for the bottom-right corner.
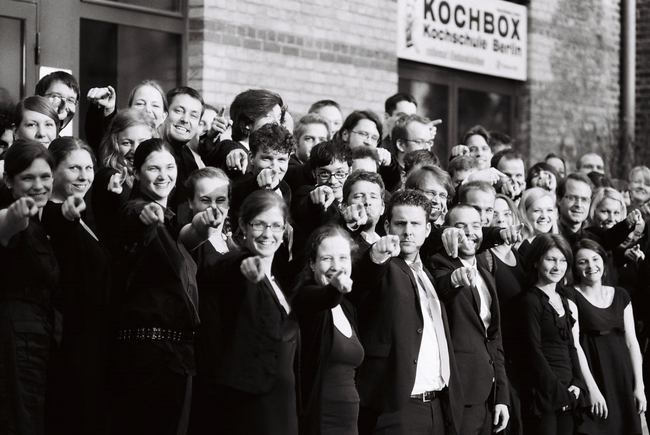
[{"x1": 428, "y1": 253, "x2": 510, "y2": 405}]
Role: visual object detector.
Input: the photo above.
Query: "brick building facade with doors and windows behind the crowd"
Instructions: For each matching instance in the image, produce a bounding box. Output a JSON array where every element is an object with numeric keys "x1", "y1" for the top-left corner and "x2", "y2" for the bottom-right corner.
[{"x1": 0, "y1": 0, "x2": 636, "y2": 177}]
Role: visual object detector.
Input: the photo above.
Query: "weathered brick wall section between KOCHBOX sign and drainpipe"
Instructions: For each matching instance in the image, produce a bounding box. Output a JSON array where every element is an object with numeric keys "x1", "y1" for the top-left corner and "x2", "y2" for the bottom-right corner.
[{"x1": 519, "y1": 0, "x2": 620, "y2": 176}]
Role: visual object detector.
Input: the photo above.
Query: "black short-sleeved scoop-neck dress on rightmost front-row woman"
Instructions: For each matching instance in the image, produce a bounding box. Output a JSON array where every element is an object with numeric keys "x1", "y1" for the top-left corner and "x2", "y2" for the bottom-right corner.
[{"x1": 567, "y1": 287, "x2": 641, "y2": 435}]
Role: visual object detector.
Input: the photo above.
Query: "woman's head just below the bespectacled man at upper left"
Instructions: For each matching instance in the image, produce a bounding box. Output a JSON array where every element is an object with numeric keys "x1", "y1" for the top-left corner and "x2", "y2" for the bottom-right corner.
[{"x1": 14, "y1": 96, "x2": 61, "y2": 148}]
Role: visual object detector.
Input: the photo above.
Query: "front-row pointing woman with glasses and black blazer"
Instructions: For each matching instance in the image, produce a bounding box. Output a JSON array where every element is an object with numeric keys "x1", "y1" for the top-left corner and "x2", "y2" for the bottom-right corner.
[{"x1": 202, "y1": 190, "x2": 299, "y2": 435}]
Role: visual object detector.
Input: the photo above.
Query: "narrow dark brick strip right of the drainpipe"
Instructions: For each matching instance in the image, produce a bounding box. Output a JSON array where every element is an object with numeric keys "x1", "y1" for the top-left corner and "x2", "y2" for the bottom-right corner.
[{"x1": 634, "y1": 0, "x2": 650, "y2": 166}]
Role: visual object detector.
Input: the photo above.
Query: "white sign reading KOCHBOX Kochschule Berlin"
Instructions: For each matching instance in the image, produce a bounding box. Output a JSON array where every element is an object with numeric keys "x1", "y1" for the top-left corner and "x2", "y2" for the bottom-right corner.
[{"x1": 397, "y1": 0, "x2": 528, "y2": 80}]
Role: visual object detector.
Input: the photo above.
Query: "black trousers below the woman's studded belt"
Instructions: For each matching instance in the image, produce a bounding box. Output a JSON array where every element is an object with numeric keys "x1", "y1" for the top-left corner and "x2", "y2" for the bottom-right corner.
[{"x1": 113, "y1": 340, "x2": 188, "y2": 435}]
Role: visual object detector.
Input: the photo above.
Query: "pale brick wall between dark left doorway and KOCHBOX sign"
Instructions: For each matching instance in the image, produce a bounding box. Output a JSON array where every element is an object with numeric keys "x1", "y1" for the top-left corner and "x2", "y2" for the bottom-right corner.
[{"x1": 188, "y1": 0, "x2": 397, "y2": 115}]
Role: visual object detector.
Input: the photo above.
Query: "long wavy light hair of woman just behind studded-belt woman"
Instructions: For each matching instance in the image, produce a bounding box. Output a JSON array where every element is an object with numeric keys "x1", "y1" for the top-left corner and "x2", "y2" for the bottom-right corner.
[{"x1": 99, "y1": 107, "x2": 158, "y2": 171}]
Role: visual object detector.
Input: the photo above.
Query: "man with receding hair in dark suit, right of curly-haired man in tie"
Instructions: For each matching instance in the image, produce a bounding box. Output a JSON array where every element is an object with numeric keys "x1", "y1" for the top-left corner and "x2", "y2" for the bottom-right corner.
[{"x1": 428, "y1": 204, "x2": 509, "y2": 435}]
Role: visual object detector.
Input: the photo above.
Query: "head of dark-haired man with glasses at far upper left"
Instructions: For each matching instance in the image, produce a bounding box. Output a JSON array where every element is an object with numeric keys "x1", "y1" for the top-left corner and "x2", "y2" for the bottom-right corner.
[{"x1": 34, "y1": 71, "x2": 79, "y2": 130}]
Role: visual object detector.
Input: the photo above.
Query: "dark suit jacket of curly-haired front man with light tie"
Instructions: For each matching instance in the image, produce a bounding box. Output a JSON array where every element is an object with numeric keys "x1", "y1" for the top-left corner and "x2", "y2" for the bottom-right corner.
[{"x1": 348, "y1": 250, "x2": 464, "y2": 429}]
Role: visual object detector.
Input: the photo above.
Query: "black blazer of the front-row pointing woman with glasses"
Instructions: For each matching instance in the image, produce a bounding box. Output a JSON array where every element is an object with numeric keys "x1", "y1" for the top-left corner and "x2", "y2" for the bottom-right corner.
[{"x1": 201, "y1": 250, "x2": 298, "y2": 394}]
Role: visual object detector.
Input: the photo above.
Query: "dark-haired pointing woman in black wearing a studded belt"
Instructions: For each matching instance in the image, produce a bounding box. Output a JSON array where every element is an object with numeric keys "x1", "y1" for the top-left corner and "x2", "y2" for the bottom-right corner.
[{"x1": 111, "y1": 139, "x2": 199, "y2": 435}]
